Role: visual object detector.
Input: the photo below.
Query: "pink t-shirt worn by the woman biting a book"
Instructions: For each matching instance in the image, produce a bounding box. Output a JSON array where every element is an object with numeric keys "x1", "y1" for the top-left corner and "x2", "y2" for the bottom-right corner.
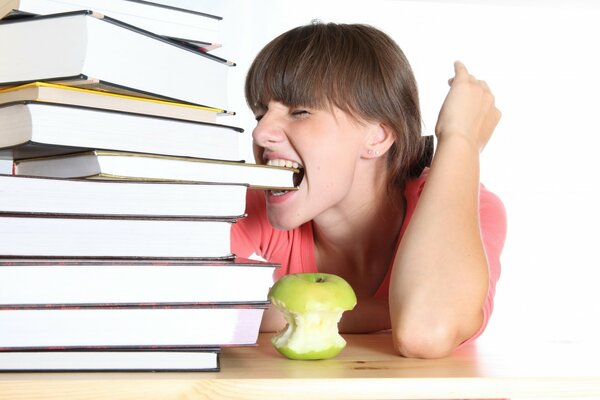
[{"x1": 231, "y1": 170, "x2": 506, "y2": 344}]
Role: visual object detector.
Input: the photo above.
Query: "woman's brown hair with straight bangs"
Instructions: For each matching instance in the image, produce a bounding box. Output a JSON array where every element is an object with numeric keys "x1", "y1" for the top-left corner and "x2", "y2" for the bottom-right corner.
[{"x1": 245, "y1": 23, "x2": 431, "y2": 194}]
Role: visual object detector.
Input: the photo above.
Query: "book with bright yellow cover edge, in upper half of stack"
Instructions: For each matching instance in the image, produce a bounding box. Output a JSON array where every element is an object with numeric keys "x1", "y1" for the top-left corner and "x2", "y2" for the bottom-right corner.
[{"x1": 0, "y1": 82, "x2": 226, "y2": 123}]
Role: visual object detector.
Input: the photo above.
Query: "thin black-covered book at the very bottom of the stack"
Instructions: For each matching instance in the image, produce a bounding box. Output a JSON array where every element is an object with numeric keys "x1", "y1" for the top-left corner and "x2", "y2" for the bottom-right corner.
[{"x1": 0, "y1": 347, "x2": 221, "y2": 372}]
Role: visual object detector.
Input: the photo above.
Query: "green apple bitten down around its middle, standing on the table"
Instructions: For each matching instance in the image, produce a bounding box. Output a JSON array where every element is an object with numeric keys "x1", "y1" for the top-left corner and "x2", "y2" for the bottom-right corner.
[{"x1": 269, "y1": 273, "x2": 356, "y2": 360}]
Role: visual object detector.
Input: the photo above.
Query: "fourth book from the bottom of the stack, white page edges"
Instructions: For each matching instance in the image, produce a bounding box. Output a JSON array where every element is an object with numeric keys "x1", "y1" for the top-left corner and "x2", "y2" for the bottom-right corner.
[{"x1": 0, "y1": 213, "x2": 234, "y2": 258}]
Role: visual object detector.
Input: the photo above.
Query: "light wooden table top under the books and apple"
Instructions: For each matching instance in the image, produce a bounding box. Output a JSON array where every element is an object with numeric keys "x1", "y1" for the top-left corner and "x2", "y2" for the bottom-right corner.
[{"x1": 0, "y1": 333, "x2": 600, "y2": 400}]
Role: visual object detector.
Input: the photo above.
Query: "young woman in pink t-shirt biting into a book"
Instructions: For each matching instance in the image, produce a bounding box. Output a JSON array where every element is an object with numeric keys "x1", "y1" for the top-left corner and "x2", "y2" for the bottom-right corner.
[{"x1": 232, "y1": 23, "x2": 506, "y2": 358}]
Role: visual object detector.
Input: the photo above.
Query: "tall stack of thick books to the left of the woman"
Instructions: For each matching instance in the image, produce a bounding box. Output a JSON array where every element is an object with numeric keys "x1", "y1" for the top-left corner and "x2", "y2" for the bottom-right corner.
[{"x1": 0, "y1": 0, "x2": 299, "y2": 371}]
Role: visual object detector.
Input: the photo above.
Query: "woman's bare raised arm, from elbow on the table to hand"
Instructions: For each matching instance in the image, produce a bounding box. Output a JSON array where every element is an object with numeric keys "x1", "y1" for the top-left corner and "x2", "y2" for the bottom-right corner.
[{"x1": 390, "y1": 63, "x2": 500, "y2": 357}]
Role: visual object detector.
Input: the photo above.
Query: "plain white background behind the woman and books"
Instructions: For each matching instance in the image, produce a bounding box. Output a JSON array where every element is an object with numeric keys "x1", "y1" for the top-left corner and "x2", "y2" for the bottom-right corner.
[{"x1": 159, "y1": 0, "x2": 600, "y2": 341}]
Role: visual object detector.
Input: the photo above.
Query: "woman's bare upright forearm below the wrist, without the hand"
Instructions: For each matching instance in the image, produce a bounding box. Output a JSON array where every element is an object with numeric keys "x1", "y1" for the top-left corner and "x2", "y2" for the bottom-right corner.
[{"x1": 390, "y1": 135, "x2": 488, "y2": 356}]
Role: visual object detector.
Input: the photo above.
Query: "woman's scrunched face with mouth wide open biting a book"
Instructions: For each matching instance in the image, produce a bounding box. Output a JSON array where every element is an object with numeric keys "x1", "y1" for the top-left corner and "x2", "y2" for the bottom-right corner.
[{"x1": 252, "y1": 101, "x2": 372, "y2": 230}]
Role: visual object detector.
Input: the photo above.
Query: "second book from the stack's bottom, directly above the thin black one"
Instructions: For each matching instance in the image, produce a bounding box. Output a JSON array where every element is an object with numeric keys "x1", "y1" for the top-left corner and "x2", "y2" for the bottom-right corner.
[{"x1": 0, "y1": 303, "x2": 268, "y2": 350}]
